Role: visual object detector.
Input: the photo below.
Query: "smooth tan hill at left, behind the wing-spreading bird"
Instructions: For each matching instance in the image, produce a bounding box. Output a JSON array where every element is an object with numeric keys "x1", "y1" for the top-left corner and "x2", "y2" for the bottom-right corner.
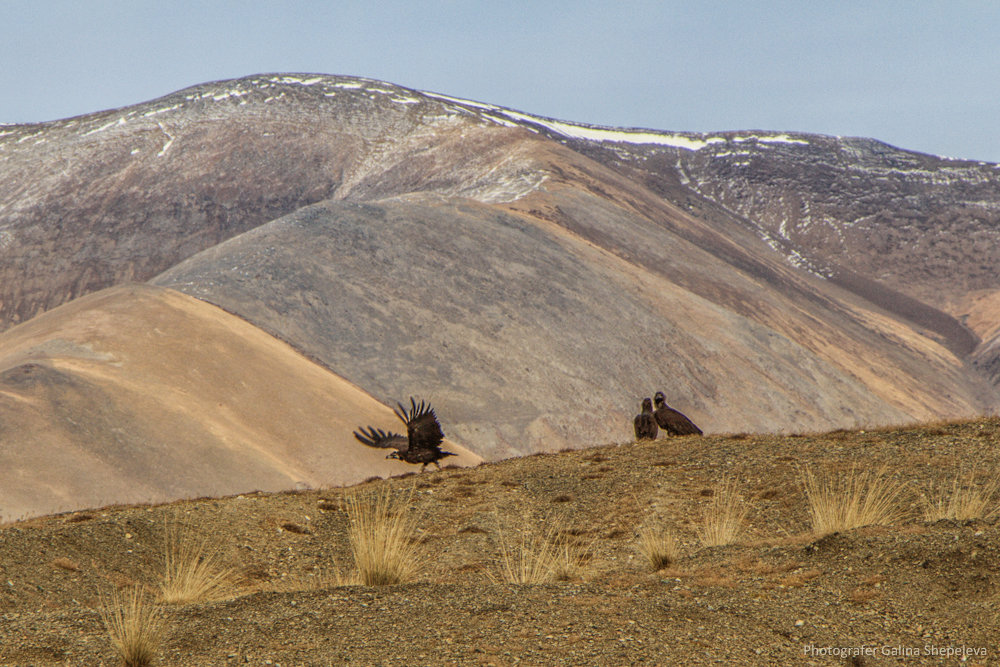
[{"x1": 0, "y1": 285, "x2": 479, "y2": 518}]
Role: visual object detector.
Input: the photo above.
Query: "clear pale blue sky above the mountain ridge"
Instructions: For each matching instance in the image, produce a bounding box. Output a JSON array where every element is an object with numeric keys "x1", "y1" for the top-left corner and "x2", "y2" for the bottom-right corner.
[{"x1": 0, "y1": 0, "x2": 1000, "y2": 162}]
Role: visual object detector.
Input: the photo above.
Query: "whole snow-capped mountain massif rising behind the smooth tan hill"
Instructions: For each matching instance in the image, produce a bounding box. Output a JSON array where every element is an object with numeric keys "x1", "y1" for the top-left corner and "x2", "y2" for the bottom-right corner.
[{"x1": 0, "y1": 74, "x2": 1000, "y2": 512}]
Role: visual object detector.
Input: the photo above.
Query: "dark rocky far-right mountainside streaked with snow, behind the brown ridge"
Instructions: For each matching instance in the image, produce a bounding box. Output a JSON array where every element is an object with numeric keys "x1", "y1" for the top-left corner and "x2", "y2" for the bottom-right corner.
[{"x1": 556, "y1": 132, "x2": 1000, "y2": 356}]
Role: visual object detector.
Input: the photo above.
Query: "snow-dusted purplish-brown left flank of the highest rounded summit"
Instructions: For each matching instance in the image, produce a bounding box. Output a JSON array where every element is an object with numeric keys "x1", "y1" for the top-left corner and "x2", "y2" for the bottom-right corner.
[{"x1": 0, "y1": 76, "x2": 532, "y2": 329}]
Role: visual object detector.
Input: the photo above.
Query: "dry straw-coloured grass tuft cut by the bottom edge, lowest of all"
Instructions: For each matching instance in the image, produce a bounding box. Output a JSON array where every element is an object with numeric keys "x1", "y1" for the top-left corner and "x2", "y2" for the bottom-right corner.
[{"x1": 100, "y1": 586, "x2": 165, "y2": 667}]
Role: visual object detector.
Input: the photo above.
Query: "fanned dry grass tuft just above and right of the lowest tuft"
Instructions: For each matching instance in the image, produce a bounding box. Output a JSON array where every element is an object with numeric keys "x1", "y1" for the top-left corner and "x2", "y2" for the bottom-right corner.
[{"x1": 160, "y1": 523, "x2": 237, "y2": 604}]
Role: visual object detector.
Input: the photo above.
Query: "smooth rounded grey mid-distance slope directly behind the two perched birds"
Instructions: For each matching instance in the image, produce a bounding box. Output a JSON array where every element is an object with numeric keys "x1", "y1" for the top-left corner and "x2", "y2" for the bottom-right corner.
[{"x1": 155, "y1": 190, "x2": 992, "y2": 458}]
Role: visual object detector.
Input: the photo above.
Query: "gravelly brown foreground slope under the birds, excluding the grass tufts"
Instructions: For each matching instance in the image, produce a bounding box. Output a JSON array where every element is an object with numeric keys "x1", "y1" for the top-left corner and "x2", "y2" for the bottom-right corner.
[{"x1": 0, "y1": 419, "x2": 1000, "y2": 666}]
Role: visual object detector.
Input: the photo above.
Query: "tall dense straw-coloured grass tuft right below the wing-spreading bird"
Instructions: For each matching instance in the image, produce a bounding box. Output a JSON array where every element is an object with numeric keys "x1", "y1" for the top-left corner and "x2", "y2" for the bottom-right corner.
[{"x1": 346, "y1": 488, "x2": 421, "y2": 586}]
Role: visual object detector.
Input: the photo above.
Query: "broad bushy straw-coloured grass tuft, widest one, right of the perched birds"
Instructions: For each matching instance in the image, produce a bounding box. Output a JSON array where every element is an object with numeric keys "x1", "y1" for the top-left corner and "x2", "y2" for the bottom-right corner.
[{"x1": 802, "y1": 468, "x2": 907, "y2": 536}]
